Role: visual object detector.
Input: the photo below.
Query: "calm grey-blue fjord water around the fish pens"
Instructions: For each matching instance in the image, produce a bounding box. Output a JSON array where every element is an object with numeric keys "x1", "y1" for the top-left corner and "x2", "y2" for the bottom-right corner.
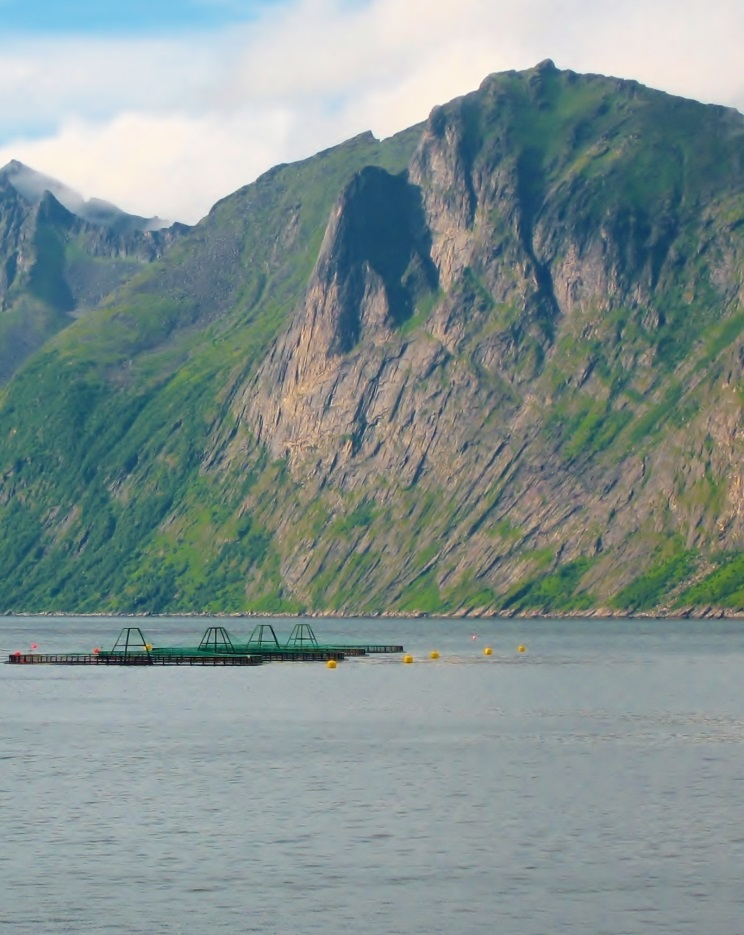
[{"x1": 0, "y1": 618, "x2": 744, "y2": 935}]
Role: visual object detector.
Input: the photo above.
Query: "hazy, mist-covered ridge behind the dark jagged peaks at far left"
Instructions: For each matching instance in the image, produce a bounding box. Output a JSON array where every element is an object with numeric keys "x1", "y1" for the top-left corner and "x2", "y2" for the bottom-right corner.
[{"x1": 0, "y1": 159, "x2": 171, "y2": 233}]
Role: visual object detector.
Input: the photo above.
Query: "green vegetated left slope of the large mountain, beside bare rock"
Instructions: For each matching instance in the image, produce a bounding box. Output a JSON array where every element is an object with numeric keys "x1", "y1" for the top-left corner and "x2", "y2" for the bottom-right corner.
[{"x1": 0, "y1": 131, "x2": 424, "y2": 611}]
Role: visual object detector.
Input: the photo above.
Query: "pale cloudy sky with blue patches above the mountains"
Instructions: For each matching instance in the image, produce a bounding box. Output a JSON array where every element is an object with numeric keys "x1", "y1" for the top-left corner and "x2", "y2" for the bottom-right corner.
[{"x1": 0, "y1": 0, "x2": 744, "y2": 223}]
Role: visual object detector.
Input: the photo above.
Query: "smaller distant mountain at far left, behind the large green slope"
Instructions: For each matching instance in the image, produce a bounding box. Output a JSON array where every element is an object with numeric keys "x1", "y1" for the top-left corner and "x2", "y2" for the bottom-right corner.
[{"x1": 0, "y1": 161, "x2": 187, "y2": 383}]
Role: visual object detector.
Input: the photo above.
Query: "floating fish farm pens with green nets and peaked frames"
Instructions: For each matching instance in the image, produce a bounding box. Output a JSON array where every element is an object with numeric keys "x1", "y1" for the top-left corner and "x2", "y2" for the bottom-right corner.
[{"x1": 6, "y1": 623, "x2": 403, "y2": 666}]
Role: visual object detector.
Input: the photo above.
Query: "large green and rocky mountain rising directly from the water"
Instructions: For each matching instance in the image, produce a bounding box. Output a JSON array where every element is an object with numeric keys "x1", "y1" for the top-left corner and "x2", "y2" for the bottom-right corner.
[{"x1": 0, "y1": 62, "x2": 744, "y2": 614}]
